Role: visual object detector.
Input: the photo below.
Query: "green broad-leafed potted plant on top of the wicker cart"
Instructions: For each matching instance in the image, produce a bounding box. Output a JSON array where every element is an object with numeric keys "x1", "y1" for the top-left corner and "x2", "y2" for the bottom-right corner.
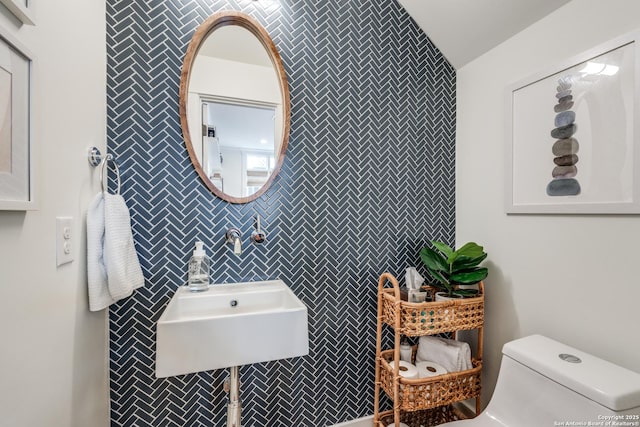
[{"x1": 420, "y1": 241, "x2": 489, "y2": 300}]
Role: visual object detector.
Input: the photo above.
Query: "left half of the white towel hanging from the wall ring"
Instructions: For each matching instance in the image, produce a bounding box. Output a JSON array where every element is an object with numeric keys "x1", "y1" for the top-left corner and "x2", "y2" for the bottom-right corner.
[{"x1": 87, "y1": 193, "x2": 115, "y2": 311}]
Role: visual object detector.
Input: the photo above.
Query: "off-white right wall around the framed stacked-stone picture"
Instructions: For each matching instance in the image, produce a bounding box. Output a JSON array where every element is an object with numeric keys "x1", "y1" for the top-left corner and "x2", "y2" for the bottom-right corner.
[{"x1": 456, "y1": 0, "x2": 640, "y2": 408}]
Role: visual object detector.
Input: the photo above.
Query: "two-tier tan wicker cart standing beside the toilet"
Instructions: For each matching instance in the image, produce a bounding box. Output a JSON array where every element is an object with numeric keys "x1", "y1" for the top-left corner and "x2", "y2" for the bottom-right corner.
[{"x1": 373, "y1": 273, "x2": 484, "y2": 427}]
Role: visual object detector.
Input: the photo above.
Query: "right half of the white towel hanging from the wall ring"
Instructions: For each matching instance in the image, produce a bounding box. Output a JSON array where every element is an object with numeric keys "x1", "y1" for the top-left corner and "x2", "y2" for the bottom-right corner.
[{"x1": 104, "y1": 193, "x2": 144, "y2": 301}]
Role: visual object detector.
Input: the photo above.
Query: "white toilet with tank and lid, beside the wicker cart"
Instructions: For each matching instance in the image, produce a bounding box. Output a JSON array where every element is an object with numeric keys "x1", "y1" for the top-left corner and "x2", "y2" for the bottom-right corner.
[{"x1": 445, "y1": 335, "x2": 640, "y2": 427}]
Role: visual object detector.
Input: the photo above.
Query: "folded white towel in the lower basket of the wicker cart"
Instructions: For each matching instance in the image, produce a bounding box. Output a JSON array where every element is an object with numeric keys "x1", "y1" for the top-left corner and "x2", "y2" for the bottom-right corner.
[{"x1": 416, "y1": 336, "x2": 473, "y2": 372}]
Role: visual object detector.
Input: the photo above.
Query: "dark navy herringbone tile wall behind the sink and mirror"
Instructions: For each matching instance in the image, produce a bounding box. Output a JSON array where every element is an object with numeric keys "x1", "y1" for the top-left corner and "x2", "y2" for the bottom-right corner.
[{"x1": 107, "y1": 0, "x2": 455, "y2": 427}]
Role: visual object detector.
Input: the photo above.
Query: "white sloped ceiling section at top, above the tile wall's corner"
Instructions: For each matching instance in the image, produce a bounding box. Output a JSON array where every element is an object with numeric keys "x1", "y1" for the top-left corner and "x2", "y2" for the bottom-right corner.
[{"x1": 398, "y1": 0, "x2": 570, "y2": 70}]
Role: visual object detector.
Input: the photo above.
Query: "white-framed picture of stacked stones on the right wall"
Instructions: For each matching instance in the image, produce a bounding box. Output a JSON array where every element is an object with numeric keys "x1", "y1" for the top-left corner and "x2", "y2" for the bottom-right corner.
[{"x1": 505, "y1": 33, "x2": 640, "y2": 214}]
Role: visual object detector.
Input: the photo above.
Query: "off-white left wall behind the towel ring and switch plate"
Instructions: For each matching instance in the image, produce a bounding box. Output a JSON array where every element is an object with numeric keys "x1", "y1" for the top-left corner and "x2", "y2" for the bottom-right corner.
[{"x1": 0, "y1": 0, "x2": 109, "y2": 427}]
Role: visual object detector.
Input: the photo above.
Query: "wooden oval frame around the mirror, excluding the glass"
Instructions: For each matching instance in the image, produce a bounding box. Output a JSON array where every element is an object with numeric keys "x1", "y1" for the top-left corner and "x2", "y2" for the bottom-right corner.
[{"x1": 180, "y1": 11, "x2": 291, "y2": 203}]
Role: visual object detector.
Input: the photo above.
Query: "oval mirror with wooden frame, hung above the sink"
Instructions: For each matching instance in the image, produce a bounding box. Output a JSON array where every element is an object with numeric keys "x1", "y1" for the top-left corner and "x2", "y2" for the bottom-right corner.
[{"x1": 180, "y1": 12, "x2": 291, "y2": 203}]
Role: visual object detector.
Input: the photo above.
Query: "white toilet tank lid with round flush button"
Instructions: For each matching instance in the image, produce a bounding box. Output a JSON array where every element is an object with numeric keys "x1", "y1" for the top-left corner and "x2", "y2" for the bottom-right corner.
[{"x1": 502, "y1": 335, "x2": 640, "y2": 411}]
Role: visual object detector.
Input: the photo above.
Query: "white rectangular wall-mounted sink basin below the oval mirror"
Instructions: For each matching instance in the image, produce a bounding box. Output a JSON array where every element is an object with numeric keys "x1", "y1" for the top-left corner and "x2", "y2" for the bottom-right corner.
[{"x1": 156, "y1": 280, "x2": 309, "y2": 378}]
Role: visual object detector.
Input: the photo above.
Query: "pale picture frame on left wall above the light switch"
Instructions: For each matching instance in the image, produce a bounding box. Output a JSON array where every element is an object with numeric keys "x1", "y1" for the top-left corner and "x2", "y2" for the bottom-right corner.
[{"x1": 0, "y1": 28, "x2": 38, "y2": 211}]
